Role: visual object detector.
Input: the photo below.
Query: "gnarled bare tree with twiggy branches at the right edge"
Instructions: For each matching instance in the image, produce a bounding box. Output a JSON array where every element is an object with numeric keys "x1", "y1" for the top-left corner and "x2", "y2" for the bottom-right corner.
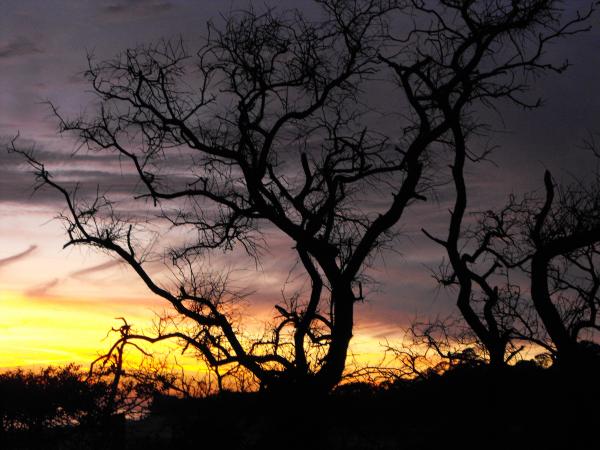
[{"x1": 472, "y1": 171, "x2": 600, "y2": 365}]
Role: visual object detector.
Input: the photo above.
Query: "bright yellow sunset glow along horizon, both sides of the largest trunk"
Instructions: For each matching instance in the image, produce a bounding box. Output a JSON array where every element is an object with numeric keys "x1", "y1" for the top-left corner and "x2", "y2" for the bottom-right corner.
[{"x1": 0, "y1": 290, "x2": 408, "y2": 384}]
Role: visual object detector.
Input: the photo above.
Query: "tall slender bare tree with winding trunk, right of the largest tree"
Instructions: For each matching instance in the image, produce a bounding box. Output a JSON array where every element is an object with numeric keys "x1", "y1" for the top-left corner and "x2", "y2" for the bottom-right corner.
[{"x1": 406, "y1": 0, "x2": 592, "y2": 366}]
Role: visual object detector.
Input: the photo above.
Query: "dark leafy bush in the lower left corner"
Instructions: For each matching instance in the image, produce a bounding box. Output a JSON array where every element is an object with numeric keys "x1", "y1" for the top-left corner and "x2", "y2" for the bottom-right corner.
[{"x1": 0, "y1": 364, "x2": 124, "y2": 449}]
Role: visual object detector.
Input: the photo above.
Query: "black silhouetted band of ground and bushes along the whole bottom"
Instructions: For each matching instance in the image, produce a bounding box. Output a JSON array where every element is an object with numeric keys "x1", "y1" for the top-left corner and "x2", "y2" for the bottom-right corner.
[{"x1": 0, "y1": 362, "x2": 600, "y2": 450}]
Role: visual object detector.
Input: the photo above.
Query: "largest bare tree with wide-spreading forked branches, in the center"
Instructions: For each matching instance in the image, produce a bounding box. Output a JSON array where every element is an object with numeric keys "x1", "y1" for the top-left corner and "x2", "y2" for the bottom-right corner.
[{"x1": 13, "y1": 0, "x2": 586, "y2": 393}]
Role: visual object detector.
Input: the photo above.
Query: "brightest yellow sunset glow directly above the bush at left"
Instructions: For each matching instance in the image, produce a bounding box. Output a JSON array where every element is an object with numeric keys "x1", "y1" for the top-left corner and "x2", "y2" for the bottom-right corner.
[{"x1": 0, "y1": 291, "x2": 207, "y2": 370}]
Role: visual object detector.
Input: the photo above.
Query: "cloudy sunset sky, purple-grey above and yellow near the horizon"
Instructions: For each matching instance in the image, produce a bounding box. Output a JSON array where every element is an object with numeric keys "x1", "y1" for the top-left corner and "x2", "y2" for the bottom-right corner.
[{"x1": 0, "y1": 0, "x2": 600, "y2": 367}]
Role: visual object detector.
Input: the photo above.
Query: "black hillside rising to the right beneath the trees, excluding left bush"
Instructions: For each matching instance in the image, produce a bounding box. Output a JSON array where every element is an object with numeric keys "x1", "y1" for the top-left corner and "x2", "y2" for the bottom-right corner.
[{"x1": 96, "y1": 361, "x2": 600, "y2": 450}]
